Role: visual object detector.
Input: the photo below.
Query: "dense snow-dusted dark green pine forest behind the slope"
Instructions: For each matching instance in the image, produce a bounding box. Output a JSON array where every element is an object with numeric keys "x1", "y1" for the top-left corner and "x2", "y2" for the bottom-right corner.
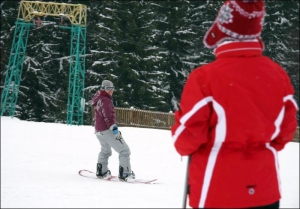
[{"x1": 0, "y1": 0, "x2": 299, "y2": 124}]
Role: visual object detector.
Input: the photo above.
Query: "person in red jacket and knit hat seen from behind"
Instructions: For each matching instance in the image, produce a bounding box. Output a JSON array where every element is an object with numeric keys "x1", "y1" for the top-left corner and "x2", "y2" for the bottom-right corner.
[{"x1": 171, "y1": 0, "x2": 298, "y2": 208}]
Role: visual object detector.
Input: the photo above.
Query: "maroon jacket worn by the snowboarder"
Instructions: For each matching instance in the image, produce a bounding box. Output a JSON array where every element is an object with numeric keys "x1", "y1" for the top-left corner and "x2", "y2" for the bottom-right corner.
[{"x1": 91, "y1": 91, "x2": 116, "y2": 132}]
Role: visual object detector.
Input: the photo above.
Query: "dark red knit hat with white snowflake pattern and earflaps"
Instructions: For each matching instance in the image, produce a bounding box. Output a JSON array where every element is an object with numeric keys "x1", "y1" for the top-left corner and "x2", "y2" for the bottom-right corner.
[{"x1": 203, "y1": 0, "x2": 265, "y2": 48}]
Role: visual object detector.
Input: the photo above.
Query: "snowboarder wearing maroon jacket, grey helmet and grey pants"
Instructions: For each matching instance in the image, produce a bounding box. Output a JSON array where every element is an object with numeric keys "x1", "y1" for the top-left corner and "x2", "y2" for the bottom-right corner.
[{"x1": 91, "y1": 80, "x2": 135, "y2": 182}]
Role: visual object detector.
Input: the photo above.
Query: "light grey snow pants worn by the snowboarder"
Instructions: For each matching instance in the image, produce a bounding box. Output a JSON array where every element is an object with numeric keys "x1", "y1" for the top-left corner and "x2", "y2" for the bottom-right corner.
[{"x1": 96, "y1": 129, "x2": 131, "y2": 173}]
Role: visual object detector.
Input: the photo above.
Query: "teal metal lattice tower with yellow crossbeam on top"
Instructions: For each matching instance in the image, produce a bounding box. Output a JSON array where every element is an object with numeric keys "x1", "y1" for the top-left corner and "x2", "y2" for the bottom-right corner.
[{"x1": 1, "y1": 1, "x2": 87, "y2": 125}]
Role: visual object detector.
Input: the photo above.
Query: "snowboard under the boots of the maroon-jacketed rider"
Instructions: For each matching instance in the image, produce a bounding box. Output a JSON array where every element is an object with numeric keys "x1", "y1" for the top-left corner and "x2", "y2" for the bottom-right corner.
[{"x1": 78, "y1": 170, "x2": 157, "y2": 184}]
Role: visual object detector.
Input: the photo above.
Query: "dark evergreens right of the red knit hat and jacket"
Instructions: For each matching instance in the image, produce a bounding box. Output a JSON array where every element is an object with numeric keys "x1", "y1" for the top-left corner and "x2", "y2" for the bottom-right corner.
[{"x1": 262, "y1": 0, "x2": 300, "y2": 119}]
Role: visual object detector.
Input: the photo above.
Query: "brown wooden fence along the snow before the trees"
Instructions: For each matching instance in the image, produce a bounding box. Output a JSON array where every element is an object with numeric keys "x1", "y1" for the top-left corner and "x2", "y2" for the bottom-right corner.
[{"x1": 115, "y1": 107, "x2": 299, "y2": 142}]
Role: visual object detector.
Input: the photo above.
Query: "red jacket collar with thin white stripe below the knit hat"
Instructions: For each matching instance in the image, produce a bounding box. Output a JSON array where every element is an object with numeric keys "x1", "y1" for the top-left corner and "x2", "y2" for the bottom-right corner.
[{"x1": 214, "y1": 42, "x2": 263, "y2": 58}]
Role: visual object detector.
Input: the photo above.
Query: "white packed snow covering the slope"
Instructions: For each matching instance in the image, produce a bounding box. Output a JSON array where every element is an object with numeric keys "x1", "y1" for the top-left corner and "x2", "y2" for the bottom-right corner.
[{"x1": 1, "y1": 117, "x2": 299, "y2": 208}]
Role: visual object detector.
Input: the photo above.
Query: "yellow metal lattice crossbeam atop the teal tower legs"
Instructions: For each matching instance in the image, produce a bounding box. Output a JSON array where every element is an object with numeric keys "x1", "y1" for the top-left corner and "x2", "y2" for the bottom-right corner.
[{"x1": 18, "y1": 0, "x2": 87, "y2": 26}]
